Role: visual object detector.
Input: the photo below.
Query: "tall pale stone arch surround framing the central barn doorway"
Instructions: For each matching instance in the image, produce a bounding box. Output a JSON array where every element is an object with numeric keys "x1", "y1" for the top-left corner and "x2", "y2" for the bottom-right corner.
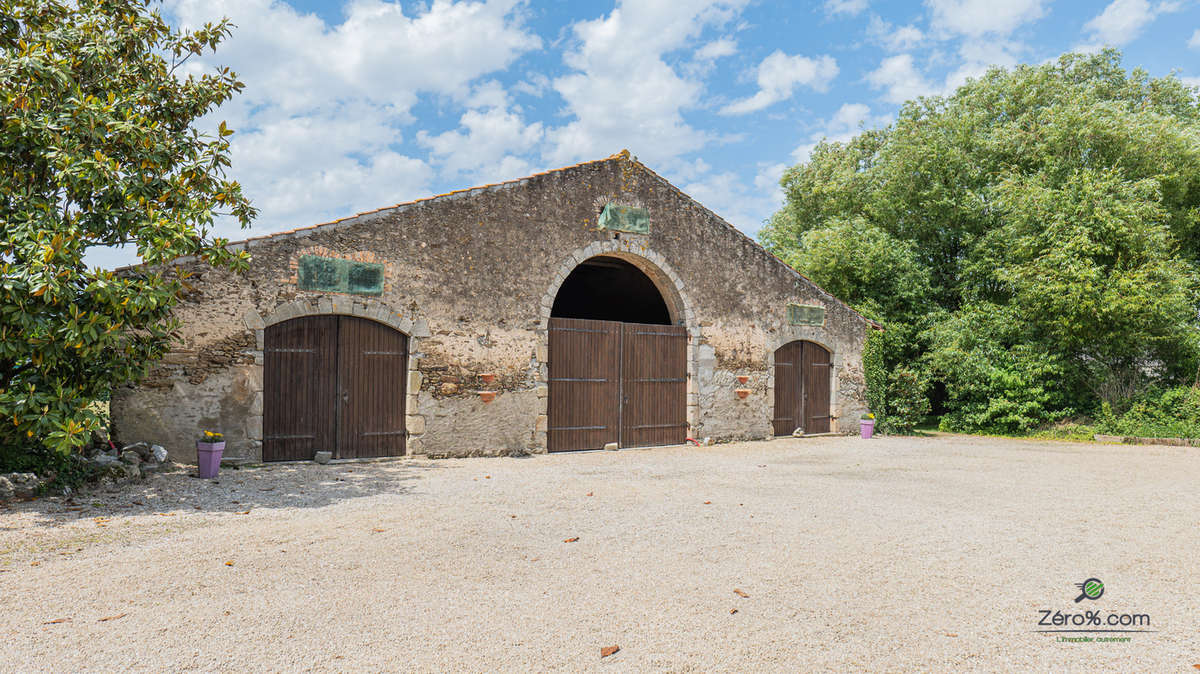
[{"x1": 533, "y1": 236, "x2": 701, "y2": 452}]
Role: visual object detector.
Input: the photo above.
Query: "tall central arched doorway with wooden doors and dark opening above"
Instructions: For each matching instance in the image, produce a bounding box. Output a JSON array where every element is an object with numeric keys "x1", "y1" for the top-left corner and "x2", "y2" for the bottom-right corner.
[{"x1": 546, "y1": 255, "x2": 688, "y2": 452}]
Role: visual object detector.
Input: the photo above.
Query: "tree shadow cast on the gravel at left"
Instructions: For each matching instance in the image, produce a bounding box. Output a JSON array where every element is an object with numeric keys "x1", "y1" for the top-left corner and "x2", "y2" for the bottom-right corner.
[{"x1": 0, "y1": 461, "x2": 439, "y2": 532}]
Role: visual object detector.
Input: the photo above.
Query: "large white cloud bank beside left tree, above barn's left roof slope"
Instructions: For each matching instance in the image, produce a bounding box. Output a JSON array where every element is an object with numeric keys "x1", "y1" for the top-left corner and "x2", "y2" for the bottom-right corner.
[{"x1": 159, "y1": 0, "x2": 541, "y2": 241}]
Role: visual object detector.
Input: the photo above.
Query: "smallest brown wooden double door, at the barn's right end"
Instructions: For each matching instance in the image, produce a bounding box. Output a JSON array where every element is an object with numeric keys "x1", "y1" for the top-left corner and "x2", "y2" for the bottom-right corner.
[{"x1": 772, "y1": 342, "x2": 833, "y2": 435}]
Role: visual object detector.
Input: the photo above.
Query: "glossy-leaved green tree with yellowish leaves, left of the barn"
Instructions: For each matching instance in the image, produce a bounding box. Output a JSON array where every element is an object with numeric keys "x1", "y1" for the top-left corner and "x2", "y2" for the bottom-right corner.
[{"x1": 0, "y1": 0, "x2": 256, "y2": 451}]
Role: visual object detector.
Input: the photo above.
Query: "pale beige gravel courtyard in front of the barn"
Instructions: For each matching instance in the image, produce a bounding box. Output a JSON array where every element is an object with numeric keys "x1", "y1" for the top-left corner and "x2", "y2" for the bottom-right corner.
[{"x1": 0, "y1": 437, "x2": 1200, "y2": 672}]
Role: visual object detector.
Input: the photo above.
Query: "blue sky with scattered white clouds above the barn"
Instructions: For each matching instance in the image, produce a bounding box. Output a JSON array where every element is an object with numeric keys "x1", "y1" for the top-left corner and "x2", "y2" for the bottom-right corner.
[{"x1": 97, "y1": 0, "x2": 1200, "y2": 261}]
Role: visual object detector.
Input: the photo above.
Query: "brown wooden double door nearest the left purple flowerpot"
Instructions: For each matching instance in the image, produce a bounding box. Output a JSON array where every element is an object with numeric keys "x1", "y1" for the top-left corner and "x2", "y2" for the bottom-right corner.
[{"x1": 263, "y1": 315, "x2": 408, "y2": 461}]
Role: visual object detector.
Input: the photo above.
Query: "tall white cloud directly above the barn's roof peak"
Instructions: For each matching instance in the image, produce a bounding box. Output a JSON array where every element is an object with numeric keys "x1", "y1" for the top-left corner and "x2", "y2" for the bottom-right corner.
[{"x1": 545, "y1": 0, "x2": 748, "y2": 167}]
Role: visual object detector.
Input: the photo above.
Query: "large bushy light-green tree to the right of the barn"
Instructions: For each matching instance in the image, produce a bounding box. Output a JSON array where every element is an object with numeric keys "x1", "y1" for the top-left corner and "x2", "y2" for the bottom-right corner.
[{"x1": 762, "y1": 50, "x2": 1200, "y2": 429}]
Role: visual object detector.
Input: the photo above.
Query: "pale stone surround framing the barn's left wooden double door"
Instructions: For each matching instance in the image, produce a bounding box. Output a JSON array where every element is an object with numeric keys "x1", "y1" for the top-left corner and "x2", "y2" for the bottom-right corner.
[{"x1": 242, "y1": 295, "x2": 430, "y2": 461}]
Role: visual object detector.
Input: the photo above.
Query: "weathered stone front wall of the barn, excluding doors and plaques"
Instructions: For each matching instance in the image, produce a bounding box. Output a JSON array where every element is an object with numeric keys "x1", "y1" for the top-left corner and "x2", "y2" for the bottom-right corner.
[{"x1": 113, "y1": 154, "x2": 869, "y2": 461}]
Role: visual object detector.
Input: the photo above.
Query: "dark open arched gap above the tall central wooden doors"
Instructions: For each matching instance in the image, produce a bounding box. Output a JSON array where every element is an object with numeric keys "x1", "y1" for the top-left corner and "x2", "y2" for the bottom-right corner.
[{"x1": 550, "y1": 257, "x2": 671, "y2": 325}]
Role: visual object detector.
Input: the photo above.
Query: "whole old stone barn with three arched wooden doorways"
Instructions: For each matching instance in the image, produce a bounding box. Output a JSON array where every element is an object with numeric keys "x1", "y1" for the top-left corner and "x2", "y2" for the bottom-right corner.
[{"x1": 112, "y1": 152, "x2": 871, "y2": 461}]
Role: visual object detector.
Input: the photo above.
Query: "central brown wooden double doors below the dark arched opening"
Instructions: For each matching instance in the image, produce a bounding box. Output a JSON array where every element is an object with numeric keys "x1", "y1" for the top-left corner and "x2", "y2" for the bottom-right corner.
[{"x1": 546, "y1": 318, "x2": 688, "y2": 452}]
